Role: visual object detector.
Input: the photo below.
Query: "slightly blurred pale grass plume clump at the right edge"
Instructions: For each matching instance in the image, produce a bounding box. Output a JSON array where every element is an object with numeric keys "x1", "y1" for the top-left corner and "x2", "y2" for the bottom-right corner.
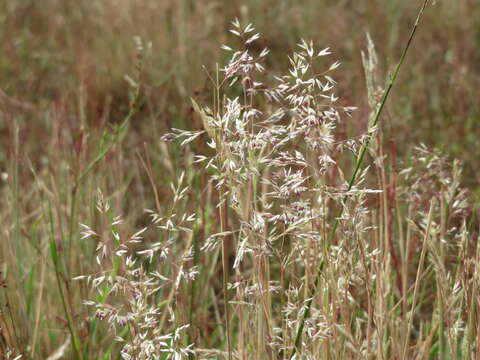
[{"x1": 399, "y1": 144, "x2": 480, "y2": 359}]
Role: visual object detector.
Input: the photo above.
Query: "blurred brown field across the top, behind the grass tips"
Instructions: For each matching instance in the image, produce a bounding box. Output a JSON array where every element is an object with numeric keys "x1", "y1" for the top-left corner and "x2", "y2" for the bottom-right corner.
[{"x1": 0, "y1": 0, "x2": 480, "y2": 190}]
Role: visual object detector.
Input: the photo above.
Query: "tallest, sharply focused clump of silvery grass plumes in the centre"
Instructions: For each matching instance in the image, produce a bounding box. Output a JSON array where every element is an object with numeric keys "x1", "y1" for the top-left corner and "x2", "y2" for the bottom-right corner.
[{"x1": 163, "y1": 21, "x2": 377, "y2": 359}]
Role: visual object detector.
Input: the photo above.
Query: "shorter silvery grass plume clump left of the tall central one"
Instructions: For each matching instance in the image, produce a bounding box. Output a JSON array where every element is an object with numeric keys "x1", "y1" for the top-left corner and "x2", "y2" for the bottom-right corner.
[{"x1": 75, "y1": 186, "x2": 197, "y2": 360}]
